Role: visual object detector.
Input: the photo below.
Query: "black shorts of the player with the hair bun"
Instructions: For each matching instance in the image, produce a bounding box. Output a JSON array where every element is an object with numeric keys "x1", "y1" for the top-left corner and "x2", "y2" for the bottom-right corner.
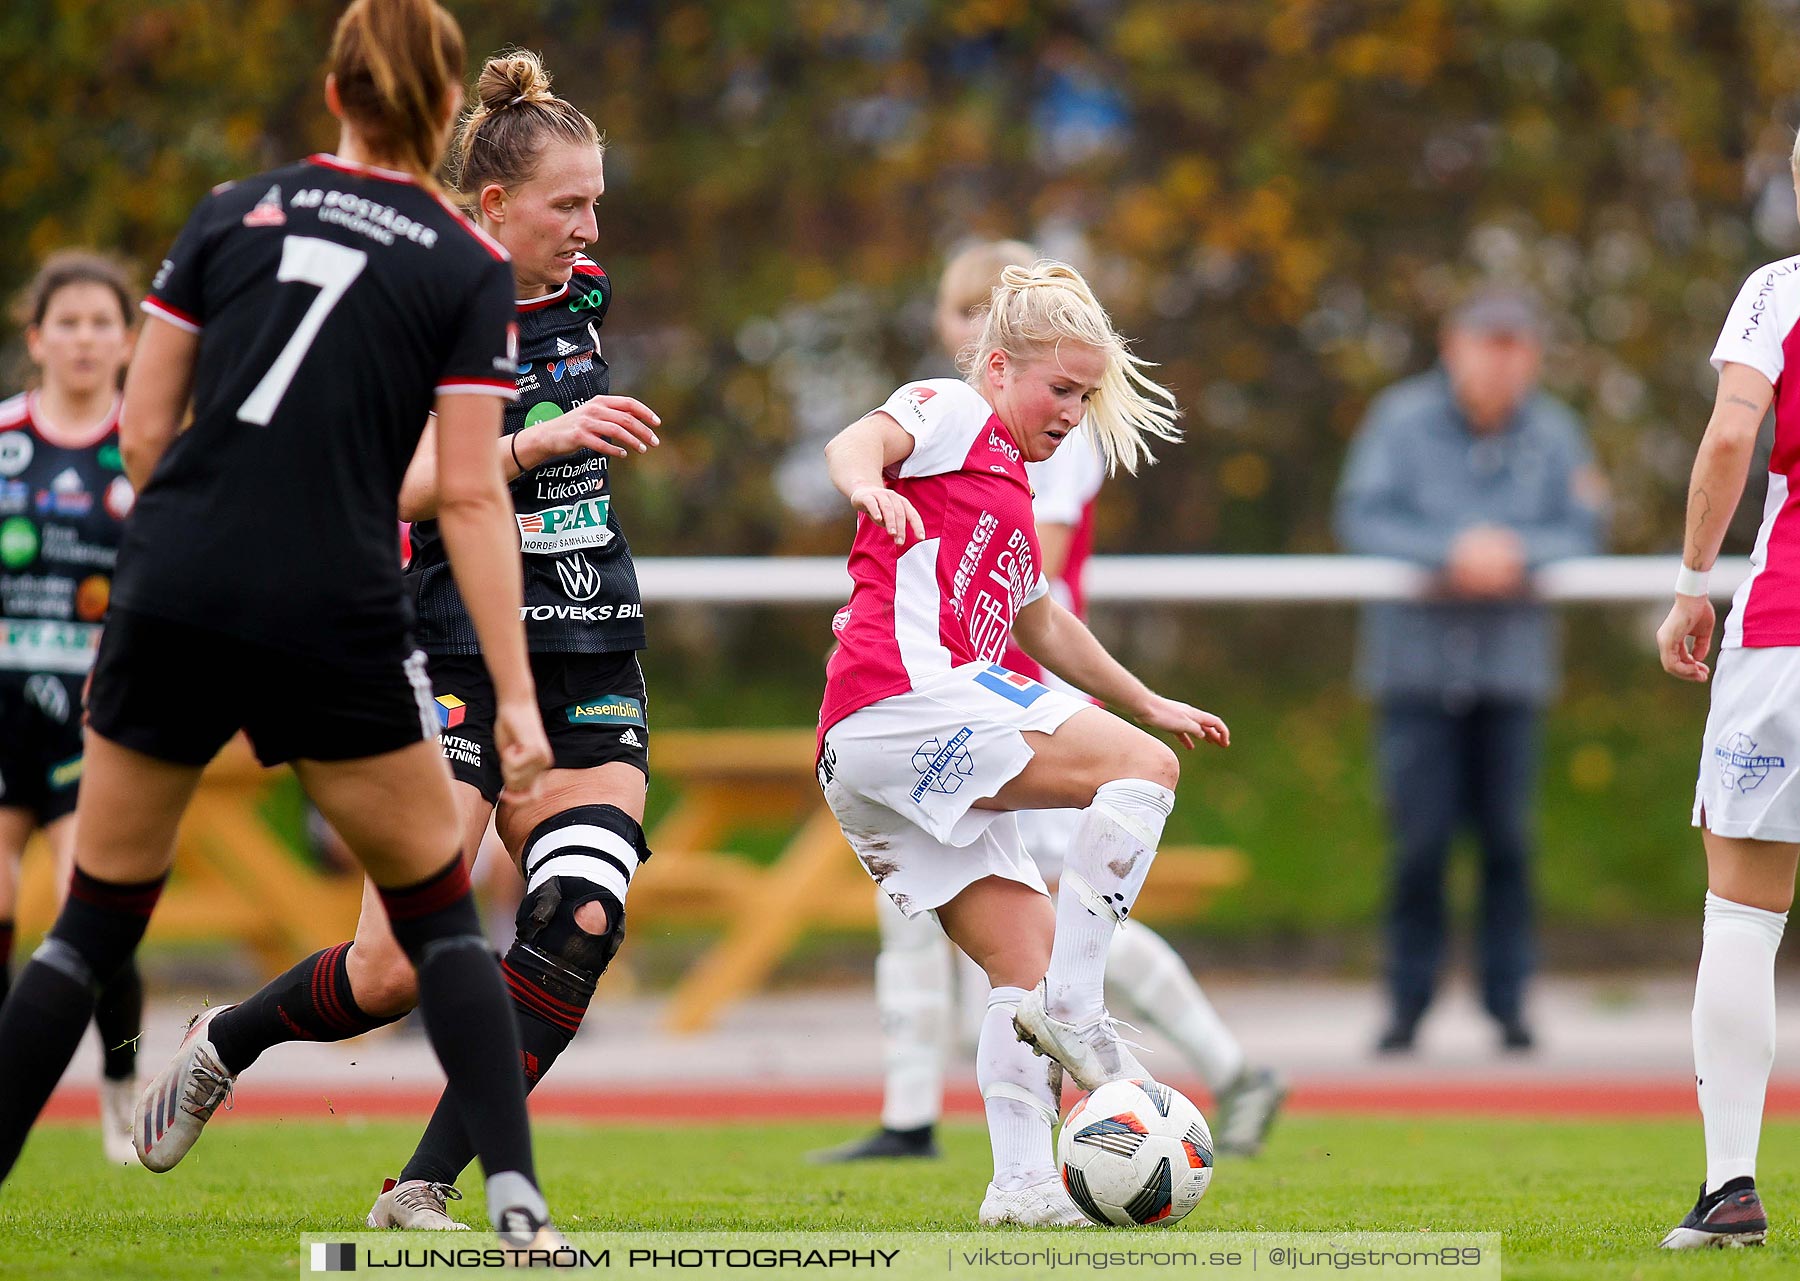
[{"x1": 428, "y1": 649, "x2": 650, "y2": 804}]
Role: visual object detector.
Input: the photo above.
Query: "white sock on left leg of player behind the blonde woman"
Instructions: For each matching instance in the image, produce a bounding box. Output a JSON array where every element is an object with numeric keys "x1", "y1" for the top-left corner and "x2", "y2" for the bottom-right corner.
[{"x1": 875, "y1": 891, "x2": 950, "y2": 1130}]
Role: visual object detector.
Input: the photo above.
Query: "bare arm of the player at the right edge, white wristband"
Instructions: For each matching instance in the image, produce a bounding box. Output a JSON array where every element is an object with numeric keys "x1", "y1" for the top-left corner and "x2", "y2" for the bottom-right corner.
[{"x1": 1656, "y1": 362, "x2": 1775, "y2": 682}]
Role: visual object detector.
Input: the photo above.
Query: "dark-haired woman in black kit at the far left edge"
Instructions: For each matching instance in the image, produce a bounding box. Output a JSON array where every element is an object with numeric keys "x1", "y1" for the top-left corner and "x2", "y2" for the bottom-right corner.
[{"x1": 0, "y1": 250, "x2": 144, "y2": 1164}]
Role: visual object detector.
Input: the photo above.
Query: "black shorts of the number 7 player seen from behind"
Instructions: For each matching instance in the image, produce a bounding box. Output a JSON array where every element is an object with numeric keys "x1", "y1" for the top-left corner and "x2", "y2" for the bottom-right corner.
[{"x1": 88, "y1": 606, "x2": 437, "y2": 765}]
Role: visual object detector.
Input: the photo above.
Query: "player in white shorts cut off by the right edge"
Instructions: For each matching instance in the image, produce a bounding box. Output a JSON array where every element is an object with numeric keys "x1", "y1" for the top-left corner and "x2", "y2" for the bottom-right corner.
[{"x1": 1656, "y1": 130, "x2": 1800, "y2": 1250}]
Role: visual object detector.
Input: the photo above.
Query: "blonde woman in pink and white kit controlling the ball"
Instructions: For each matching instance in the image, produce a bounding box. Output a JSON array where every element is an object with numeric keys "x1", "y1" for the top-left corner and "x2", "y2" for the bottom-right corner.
[{"x1": 819, "y1": 261, "x2": 1229, "y2": 1225}]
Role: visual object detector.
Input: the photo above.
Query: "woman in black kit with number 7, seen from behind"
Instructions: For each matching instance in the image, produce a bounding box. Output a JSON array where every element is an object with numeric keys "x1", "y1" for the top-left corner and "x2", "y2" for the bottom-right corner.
[{"x1": 0, "y1": 0, "x2": 560, "y2": 1247}]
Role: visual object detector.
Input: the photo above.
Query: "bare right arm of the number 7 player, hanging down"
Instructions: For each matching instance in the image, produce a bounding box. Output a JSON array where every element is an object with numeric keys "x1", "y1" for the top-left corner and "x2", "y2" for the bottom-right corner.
[{"x1": 437, "y1": 396, "x2": 551, "y2": 801}]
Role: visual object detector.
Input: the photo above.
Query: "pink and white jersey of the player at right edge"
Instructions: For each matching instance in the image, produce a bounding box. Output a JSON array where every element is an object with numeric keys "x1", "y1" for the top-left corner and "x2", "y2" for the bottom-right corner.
[{"x1": 1712, "y1": 257, "x2": 1800, "y2": 649}]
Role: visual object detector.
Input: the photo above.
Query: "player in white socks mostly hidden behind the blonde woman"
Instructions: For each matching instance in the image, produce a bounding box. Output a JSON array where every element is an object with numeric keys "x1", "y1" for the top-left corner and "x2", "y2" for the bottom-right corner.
[{"x1": 812, "y1": 241, "x2": 1285, "y2": 1162}]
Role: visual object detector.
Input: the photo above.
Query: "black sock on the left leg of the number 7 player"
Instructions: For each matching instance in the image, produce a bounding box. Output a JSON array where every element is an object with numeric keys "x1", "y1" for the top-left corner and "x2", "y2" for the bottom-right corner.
[{"x1": 0, "y1": 867, "x2": 167, "y2": 1180}]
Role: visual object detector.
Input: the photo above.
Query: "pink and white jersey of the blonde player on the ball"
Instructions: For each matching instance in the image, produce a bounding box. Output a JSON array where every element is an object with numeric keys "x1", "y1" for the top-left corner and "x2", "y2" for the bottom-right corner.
[{"x1": 819, "y1": 378, "x2": 1049, "y2": 741}]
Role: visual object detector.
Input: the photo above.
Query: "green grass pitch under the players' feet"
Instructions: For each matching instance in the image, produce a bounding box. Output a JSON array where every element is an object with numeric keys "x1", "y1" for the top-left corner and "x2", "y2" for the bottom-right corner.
[{"x1": 0, "y1": 1115, "x2": 1800, "y2": 1281}]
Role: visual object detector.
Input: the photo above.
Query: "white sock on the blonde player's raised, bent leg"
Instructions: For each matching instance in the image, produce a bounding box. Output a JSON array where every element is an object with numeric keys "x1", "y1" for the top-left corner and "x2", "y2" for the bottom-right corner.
[{"x1": 1044, "y1": 779, "x2": 1175, "y2": 1026}]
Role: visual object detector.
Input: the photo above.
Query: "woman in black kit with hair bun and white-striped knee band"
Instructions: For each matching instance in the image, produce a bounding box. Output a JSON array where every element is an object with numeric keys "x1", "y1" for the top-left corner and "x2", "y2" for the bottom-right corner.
[{"x1": 145, "y1": 52, "x2": 659, "y2": 1229}]
